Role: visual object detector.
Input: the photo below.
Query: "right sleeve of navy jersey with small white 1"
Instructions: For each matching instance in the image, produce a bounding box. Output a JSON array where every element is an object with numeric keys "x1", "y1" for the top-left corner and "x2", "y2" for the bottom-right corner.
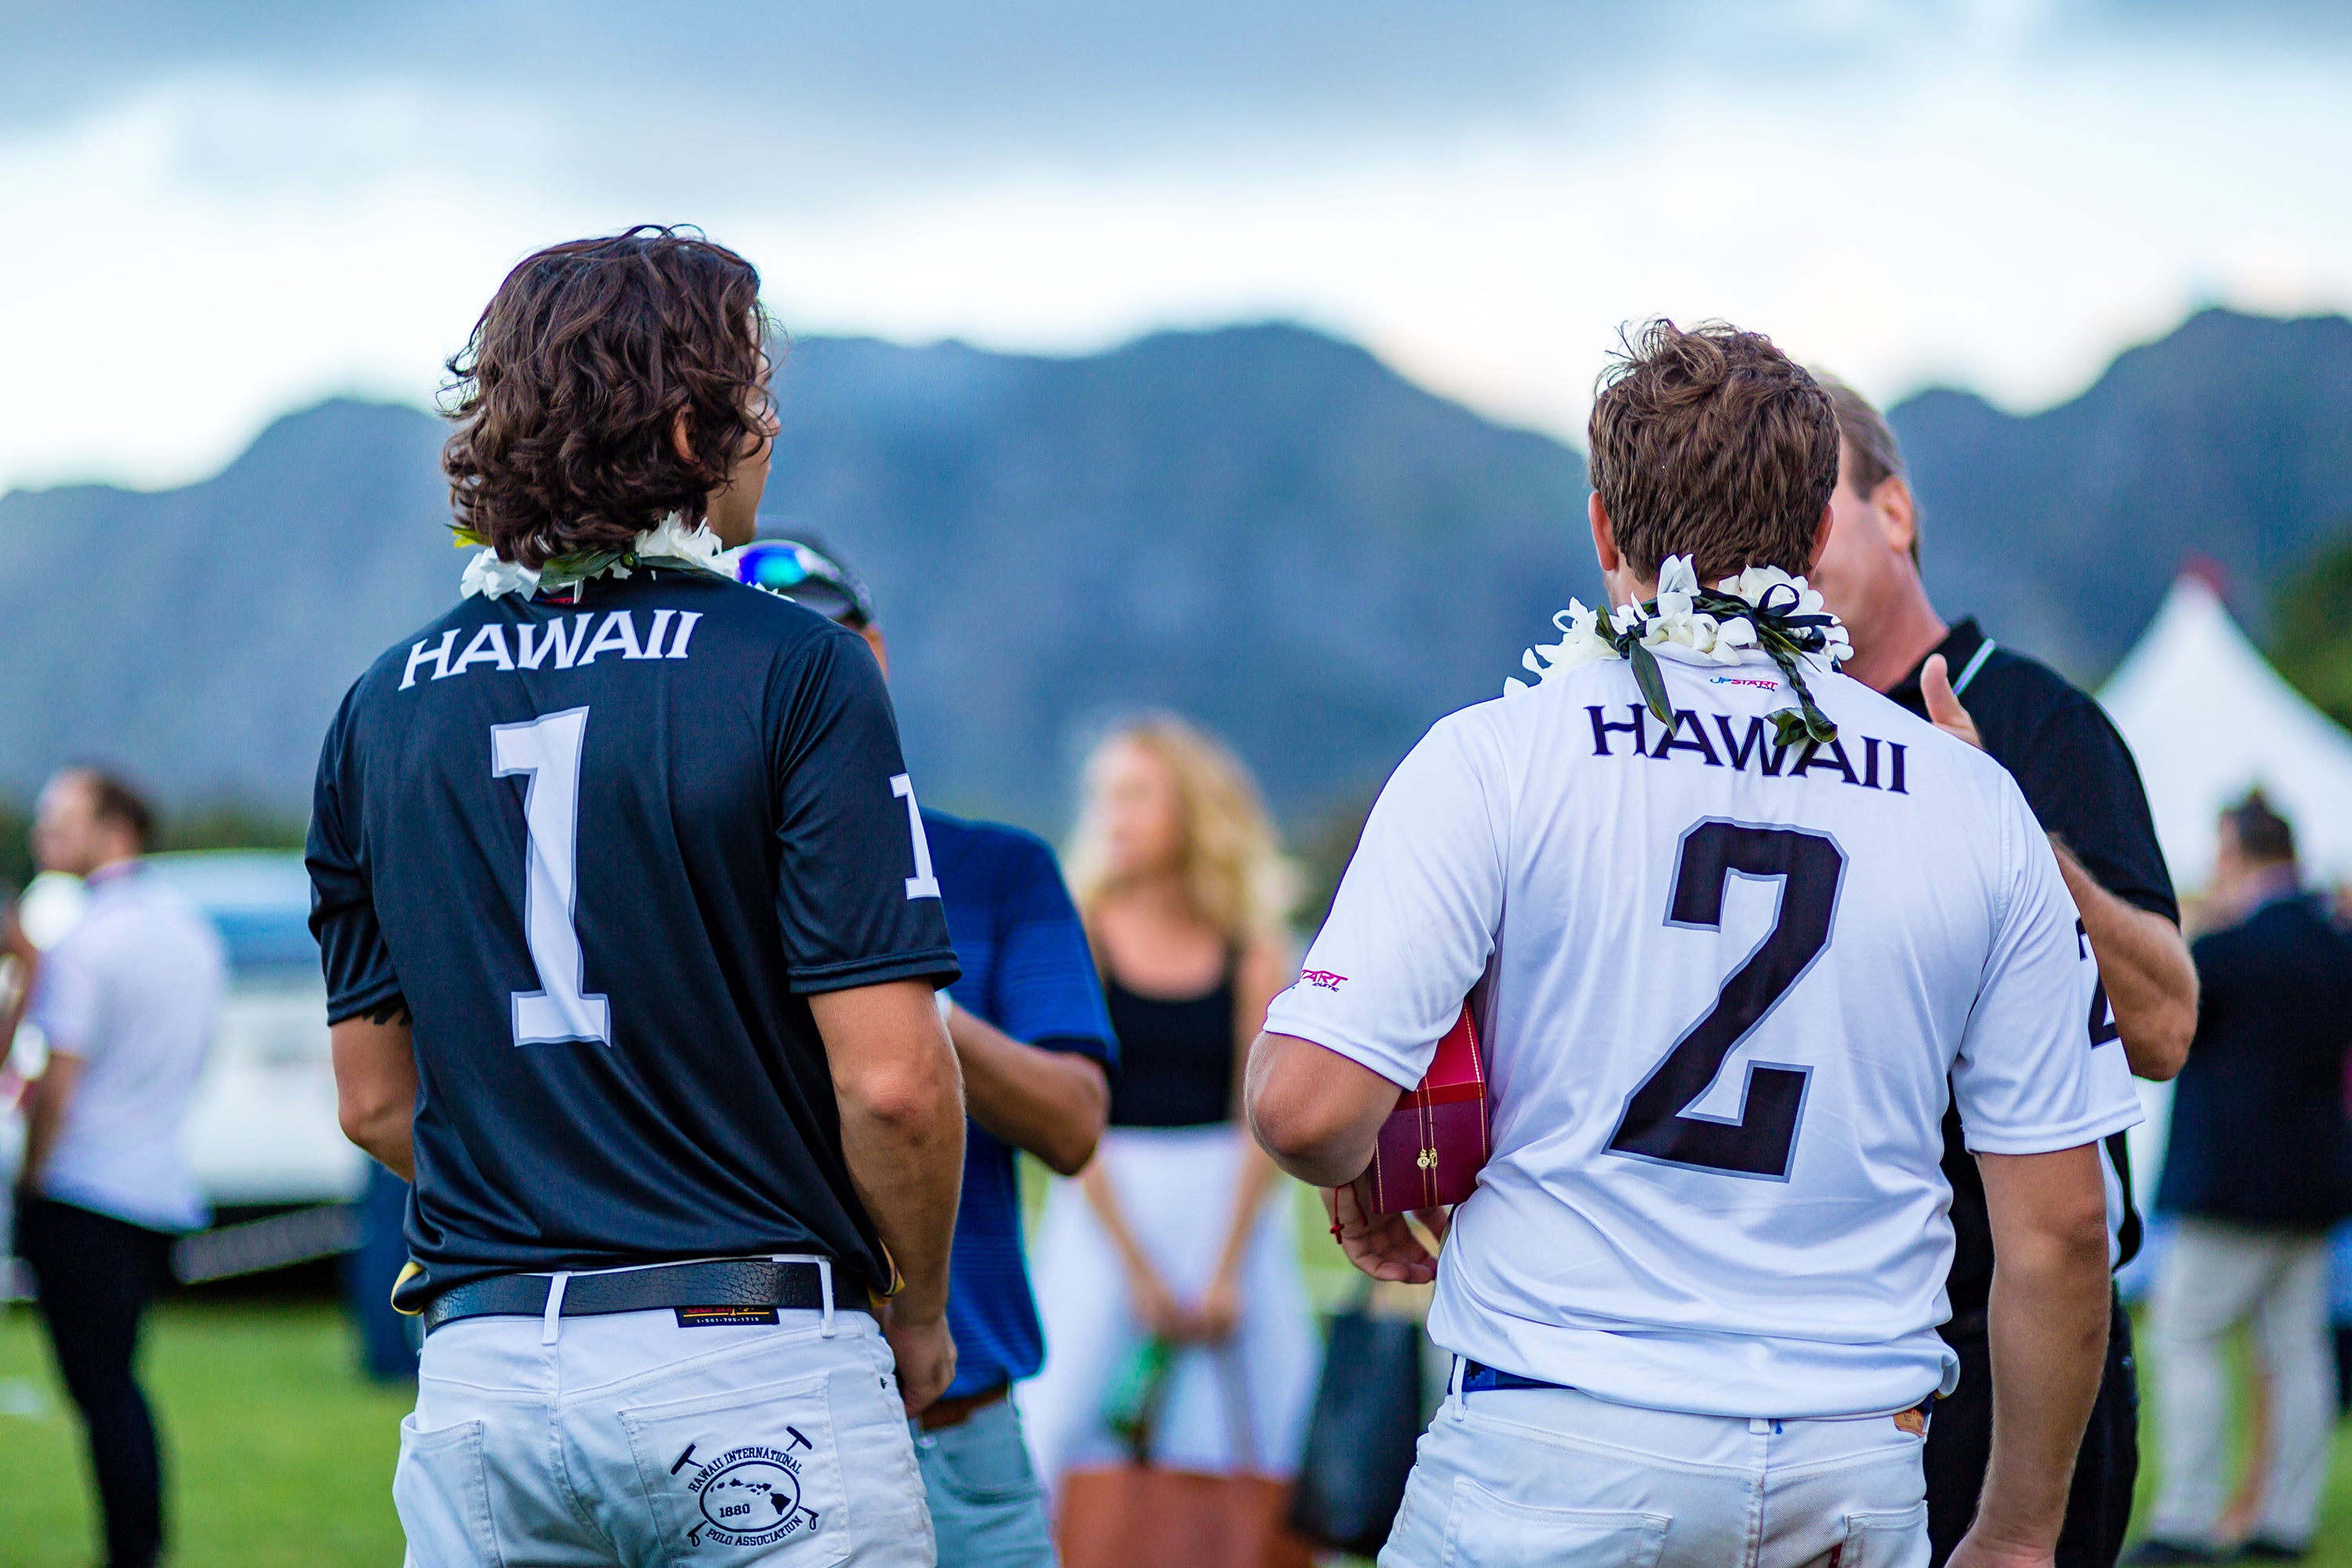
[{"x1": 769, "y1": 628, "x2": 957, "y2": 994}]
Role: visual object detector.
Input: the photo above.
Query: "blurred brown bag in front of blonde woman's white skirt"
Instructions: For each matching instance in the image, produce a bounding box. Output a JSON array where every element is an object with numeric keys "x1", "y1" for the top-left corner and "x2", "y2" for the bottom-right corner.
[{"x1": 1054, "y1": 1340, "x2": 1315, "y2": 1568}]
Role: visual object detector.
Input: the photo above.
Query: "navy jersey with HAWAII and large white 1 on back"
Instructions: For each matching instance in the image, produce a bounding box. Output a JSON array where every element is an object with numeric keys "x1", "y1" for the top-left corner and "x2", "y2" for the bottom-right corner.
[{"x1": 308, "y1": 562, "x2": 955, "y2": 1307}]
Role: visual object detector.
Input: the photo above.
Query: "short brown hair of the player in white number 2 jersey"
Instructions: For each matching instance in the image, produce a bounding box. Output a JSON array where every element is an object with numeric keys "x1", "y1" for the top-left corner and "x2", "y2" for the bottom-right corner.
[{"x1": 1588, "y1": 318, "x2": 1837, "y2": 583}]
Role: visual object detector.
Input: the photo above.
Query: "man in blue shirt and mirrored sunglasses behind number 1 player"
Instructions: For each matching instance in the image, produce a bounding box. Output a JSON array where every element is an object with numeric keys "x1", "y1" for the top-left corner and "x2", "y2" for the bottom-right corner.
[{"x1": 736, "y1": 541, "x2": 1117, "y2": 1568}]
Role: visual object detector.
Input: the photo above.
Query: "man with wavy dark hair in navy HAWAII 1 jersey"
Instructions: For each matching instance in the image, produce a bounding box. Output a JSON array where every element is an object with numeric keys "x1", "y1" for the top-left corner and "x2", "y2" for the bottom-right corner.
[{"x1": 308, "y1": 230, "x2": 964, "y2": 1568}]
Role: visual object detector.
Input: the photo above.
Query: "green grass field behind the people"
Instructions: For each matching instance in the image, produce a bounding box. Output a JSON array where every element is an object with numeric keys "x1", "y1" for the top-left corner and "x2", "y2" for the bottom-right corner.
[{"x1": 0, "y1": 1288, "x2": 2352, "y2": 1568}]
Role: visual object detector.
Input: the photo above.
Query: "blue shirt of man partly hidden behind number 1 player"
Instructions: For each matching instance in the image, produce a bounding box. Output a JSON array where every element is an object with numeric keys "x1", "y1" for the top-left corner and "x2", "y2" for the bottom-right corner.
[{"x1": 922, "y1": 811, "x2": 1117, "y2": 1399}]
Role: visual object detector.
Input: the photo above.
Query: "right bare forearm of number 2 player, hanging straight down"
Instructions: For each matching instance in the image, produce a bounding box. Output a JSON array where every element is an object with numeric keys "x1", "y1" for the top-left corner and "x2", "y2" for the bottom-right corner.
[{"x1": 1976, "y1": 1145, "x2": 2112, "y2": 1552}]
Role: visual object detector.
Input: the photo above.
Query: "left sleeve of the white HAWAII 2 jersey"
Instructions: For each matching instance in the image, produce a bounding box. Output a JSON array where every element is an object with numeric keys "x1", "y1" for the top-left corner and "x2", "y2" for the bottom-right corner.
[{"x1": 1265, "y1": 710, "x2": 1510, "y2": 1088}]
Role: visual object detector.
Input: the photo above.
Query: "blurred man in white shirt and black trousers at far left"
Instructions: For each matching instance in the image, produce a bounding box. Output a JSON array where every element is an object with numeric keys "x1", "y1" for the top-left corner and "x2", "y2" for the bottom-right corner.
[{"x1": 16, "y1": 769, "x2": 228, "y2": 1568}]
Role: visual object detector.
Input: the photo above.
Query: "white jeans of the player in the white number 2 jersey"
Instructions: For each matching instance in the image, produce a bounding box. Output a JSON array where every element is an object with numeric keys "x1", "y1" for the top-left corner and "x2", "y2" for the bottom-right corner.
[{"x1": 1381, "y1": 1389, "x2": 1929, "y2": 1568}]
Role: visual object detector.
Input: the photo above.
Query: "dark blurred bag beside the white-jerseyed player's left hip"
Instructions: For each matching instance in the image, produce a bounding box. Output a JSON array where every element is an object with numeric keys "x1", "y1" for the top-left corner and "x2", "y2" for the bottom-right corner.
[{"x1": 1289, "y1": 1281, "x2": 1428, "y2": 1556}]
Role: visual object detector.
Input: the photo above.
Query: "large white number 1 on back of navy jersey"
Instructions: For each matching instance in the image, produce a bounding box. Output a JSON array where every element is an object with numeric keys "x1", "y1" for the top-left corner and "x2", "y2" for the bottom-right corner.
[{"x1": 489, "y1": 708, "x2": 612, "y2": 1046}]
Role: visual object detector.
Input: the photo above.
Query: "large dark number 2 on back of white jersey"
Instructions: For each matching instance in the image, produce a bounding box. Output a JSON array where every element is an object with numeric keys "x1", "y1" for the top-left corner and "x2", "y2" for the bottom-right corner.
[{"x1": 1609, "y1": 820, "x2": 1846, "y2": 1182}]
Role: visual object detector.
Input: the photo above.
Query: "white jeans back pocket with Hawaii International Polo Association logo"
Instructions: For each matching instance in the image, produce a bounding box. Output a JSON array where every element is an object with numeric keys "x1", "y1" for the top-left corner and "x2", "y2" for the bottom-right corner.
[{"x1": 621, "y1": 1373, "x2": 851, "y2": 1568}]
